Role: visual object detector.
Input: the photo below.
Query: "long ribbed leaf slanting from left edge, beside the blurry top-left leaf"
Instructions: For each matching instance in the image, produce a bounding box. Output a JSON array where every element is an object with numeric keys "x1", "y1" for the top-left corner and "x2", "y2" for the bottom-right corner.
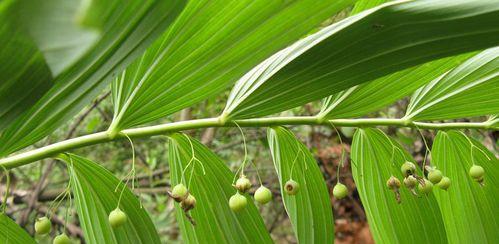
[{"x1": 0, "y1": 0, "x2": 185, "y2": 155}]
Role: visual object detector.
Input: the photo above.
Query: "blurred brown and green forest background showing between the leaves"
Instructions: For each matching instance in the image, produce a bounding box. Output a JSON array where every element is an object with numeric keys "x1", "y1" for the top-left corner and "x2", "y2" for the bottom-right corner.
[{"x1": 0, "y1": 86, "x2": 499, "y2": 244}]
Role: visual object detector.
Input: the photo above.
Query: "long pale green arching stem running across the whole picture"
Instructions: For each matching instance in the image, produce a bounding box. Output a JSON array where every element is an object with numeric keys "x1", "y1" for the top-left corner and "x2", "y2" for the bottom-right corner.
[{"x1": 0, "y1": 116, "x2": 499, "y2": 169}]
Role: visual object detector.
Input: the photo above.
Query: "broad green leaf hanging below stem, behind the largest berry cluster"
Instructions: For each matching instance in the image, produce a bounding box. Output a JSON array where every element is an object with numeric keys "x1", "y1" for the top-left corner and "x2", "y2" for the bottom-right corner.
[{"x1": 352, "y1": 129, "x2": 447, "y2": 243}]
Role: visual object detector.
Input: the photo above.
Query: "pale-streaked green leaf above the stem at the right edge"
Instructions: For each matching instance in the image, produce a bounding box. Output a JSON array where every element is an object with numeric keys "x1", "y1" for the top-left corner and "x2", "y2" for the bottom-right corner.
[{"x1": 404, "y1": 48, "x2": 499, "y2": 120}]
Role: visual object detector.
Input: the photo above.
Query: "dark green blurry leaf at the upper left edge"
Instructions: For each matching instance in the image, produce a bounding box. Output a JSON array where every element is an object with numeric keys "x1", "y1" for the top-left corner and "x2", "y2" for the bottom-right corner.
[{"x1": 0, "y1": 1, "x2": 53, "y2": 132}]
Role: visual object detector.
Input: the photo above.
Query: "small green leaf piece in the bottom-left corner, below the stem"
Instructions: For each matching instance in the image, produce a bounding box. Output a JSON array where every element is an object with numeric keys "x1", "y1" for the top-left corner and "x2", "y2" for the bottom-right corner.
[{"x1": 0, "y1": 213, "x2": 36, "y2": 244}]
